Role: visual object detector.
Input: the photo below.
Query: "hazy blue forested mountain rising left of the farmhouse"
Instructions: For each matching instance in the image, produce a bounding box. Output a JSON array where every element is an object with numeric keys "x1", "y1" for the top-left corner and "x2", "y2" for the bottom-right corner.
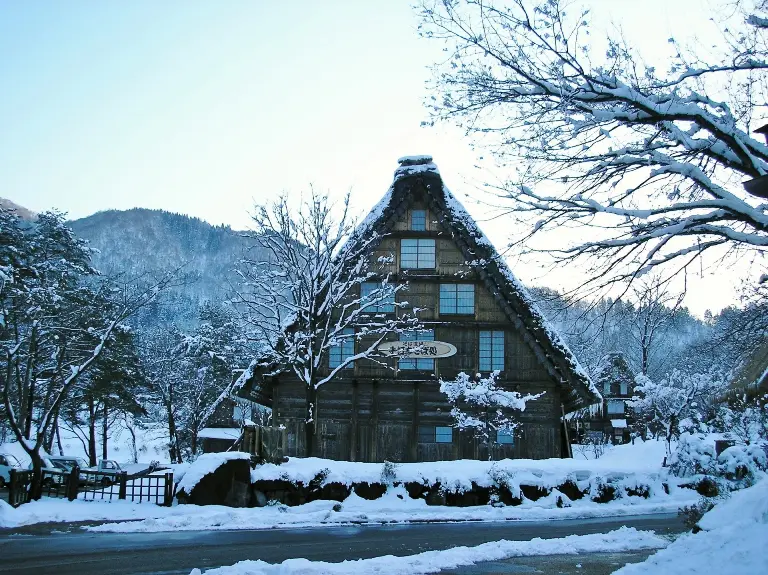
[{"x1": 70, "y1": 208, "x2": 251, "y2": 328}]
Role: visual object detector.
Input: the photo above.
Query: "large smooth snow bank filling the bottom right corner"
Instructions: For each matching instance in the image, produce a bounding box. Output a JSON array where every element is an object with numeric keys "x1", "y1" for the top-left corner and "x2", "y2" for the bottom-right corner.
[{"x1": 614, "y1": 479, "x2": 768, "y2": 575}]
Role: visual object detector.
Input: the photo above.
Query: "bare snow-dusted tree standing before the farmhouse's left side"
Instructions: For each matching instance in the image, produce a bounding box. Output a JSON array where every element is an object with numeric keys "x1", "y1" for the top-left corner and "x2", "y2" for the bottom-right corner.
[{"x1": 236, "y1": 191, "x2": 419, "y2": 450}]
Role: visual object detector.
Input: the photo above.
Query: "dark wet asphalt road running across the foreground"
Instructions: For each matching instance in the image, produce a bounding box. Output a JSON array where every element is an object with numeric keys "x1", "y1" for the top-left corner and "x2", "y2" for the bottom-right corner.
[{"x1": 0, "y1": 515, "x2": 684, "y2": 575}]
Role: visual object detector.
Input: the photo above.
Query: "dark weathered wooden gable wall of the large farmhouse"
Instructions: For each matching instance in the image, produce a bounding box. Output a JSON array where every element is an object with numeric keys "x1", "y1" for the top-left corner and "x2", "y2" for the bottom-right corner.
[{"x1": 273, "y1": 182, "x2": 561, "y2": 461}]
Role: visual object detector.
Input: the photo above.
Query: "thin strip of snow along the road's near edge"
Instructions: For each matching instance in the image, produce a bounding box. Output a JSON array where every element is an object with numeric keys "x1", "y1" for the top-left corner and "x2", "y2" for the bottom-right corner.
[{"x1": 190, "y1": 527, "x2": 668, "y2": 575}]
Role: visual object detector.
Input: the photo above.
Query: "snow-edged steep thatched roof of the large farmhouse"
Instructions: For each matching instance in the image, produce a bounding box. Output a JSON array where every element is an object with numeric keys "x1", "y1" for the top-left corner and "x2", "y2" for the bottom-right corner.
[{"x1": 351, "y1": 156, "x2": 602, "y2": 410}]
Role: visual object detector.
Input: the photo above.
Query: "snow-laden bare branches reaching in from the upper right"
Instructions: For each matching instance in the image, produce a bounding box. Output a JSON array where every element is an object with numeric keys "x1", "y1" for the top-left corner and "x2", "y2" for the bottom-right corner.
[{"x1": 420, "y1": 0, "x2": 768, "y2": 293}]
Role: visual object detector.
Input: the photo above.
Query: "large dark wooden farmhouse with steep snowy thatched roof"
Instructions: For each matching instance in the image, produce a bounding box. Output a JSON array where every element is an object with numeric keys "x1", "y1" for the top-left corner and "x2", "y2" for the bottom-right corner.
[{"x1": 238, "y1": 156, "x2": 601, "y2": 462}]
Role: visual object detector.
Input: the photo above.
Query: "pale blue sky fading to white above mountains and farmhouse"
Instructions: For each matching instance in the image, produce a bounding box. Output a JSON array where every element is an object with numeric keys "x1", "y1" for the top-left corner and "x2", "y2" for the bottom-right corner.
[{"x1": 0, "y1": 0, "x2": 732, "y2": 312}]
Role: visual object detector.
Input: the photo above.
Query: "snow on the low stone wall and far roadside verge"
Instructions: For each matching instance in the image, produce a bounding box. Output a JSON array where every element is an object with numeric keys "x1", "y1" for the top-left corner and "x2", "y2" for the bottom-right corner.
[{"x1": 0, "y1": 442, "x2": 698, "y2": 532}]
